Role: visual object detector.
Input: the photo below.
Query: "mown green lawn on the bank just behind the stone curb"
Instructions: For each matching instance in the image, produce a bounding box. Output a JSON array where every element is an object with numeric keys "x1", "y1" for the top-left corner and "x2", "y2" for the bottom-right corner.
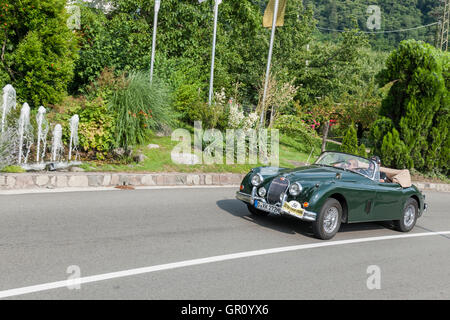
[{"x1": 82, "y1": 136, "x2": 339, "y2": 173}]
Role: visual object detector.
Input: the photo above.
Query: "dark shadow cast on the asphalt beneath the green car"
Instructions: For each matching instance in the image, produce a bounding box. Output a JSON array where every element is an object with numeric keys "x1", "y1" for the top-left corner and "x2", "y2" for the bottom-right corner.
[{"x1": 217, "y1": 199, "x2": 392, "y2": 238}]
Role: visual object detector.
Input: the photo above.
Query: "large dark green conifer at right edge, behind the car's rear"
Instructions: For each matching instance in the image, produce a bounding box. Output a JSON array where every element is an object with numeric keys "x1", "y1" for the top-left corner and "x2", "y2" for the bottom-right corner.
[{"x1": 372, "y1": 40, "x2": 450, "y2": 174}]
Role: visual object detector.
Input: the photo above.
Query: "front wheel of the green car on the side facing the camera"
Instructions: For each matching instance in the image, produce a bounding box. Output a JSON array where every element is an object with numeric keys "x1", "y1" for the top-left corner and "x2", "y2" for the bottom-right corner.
[{"x1": 312, "y1": 198, "x2": 342, "y2": 240}]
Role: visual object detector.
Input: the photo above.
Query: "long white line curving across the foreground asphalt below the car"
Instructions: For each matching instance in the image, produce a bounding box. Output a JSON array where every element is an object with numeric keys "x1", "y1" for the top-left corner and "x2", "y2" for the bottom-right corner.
[{"x1": 0, "y1": 231, "x2": 450, "y2": 298}]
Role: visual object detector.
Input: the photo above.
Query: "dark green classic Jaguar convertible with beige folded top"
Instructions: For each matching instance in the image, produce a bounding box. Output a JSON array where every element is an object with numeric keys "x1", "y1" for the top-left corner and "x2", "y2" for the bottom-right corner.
[{"x1": 236, "y1": 152, "x2": 427, "y2": 240}]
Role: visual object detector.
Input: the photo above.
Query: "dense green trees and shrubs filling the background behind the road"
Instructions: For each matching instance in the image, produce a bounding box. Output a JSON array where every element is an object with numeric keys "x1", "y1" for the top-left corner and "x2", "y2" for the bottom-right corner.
[{"x1": 0, "y1": 0, "x2": 450, "y2": 180}]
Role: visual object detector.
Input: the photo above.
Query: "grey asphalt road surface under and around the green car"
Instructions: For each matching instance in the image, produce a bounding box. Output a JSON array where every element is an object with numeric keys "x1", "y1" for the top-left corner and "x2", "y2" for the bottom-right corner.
[{"x1": 0, "y1": 188, "x2": 450, "y2": 299}]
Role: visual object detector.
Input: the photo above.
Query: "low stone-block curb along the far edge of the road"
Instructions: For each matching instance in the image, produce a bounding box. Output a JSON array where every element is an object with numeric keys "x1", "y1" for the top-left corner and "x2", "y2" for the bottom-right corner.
[{"x1": 0, "y1": 172, "x2": 450, "y2": 192}]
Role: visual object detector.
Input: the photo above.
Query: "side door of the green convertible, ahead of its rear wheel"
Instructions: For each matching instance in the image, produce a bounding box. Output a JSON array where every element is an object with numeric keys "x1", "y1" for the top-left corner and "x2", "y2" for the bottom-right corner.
[{"x1": 373, "y1": 182, "x2": 404, "y2": 221}]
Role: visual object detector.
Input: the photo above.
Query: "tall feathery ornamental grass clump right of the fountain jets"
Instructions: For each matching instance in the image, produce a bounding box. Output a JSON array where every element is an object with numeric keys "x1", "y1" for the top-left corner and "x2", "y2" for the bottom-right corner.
[{"x1": 109, "y1": 72, "x2": 176, "y2": 148}]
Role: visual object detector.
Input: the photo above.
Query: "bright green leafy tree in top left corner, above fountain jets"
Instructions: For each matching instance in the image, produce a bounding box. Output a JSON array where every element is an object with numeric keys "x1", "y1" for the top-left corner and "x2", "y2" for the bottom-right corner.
[{"x1": 0, "y1": 0, "x2": 77, "y2": 107}]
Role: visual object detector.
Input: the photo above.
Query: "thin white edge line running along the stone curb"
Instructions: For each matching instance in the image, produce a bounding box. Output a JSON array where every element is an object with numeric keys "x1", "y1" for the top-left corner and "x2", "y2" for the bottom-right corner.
[{"x1": 0, "y1": 184, "x2": 239, "y2": 196}]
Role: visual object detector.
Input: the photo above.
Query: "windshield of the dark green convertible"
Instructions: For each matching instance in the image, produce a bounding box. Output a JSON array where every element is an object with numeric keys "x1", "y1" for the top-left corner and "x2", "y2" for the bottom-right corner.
[{"x1": 315, "y1": 152, "x2": 376, "y2": 179}]
